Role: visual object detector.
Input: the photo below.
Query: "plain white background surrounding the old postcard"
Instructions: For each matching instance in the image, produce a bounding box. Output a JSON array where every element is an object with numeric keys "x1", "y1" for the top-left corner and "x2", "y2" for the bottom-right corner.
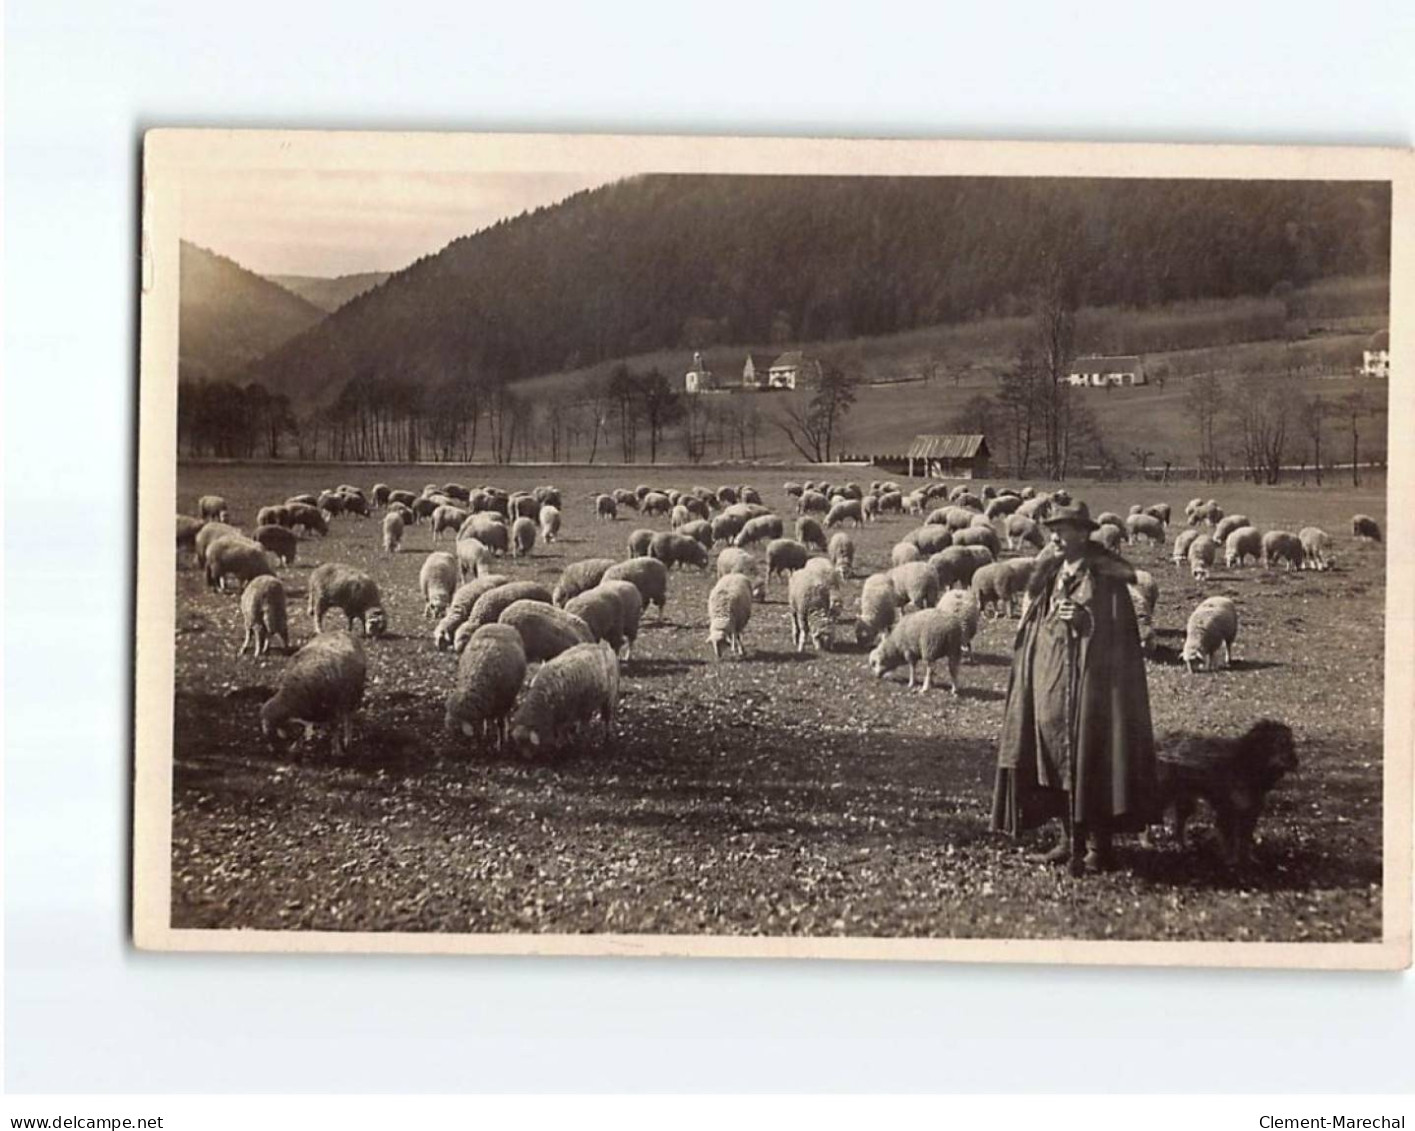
[{"x1": 4, "y1": 0, "x2": 1415, "y2": 1091}]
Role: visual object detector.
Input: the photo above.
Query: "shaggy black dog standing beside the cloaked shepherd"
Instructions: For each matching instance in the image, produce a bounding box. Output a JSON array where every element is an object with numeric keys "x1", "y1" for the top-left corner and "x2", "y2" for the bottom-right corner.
[{"x1": 1156, "y1": 719, "x2": 1298, "y2": 866}]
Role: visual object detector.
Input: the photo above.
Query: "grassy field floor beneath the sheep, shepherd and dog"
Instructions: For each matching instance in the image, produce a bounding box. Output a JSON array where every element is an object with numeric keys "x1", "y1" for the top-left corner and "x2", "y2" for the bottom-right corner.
[{"x1": 171, "y1": 464, "x2": 1385, "y2": 941}]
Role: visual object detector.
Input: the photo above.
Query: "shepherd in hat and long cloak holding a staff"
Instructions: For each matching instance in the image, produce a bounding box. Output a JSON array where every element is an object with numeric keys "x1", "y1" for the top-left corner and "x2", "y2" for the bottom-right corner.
[{"x1": 992, "y1": 503, "x2": 1155, "y2": 876}]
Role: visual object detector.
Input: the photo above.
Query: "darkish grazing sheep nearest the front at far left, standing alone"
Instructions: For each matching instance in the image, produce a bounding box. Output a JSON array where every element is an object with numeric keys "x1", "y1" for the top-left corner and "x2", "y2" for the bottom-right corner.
[{"x1": 260, "y1": 631, "x2": 368, "y2": 757}]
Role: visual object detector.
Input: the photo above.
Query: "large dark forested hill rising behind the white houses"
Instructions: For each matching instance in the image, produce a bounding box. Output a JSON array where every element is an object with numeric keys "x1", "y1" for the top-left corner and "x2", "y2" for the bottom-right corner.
[{"x1": 246, "y1": 176, "x2": 1390, "y2": 403}]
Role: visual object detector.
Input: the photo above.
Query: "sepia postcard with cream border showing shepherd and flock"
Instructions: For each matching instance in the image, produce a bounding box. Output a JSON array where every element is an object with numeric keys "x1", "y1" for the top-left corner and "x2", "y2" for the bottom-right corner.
[{"x1": 133, "y1": 130, "x2": 1415, "y2": 968}]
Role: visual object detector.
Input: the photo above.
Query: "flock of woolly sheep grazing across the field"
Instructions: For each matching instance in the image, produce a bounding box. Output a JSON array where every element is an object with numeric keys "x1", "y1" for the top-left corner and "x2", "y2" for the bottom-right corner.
[{"x1": 177, "y1": 481, "x2": 1381, "y2": 753}]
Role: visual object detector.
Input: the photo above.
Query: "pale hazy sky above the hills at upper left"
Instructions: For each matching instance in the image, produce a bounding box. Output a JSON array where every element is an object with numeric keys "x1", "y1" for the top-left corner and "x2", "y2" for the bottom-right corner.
[{"x1": 183, "y1": 170, "x2": 627, "y2": 276}]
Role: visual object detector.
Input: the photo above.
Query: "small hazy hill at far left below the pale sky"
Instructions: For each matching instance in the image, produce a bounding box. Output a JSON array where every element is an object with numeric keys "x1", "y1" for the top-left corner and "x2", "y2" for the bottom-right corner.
[{"x1": 177, "y1": 241, "x2": 324, "y2": 381}]
